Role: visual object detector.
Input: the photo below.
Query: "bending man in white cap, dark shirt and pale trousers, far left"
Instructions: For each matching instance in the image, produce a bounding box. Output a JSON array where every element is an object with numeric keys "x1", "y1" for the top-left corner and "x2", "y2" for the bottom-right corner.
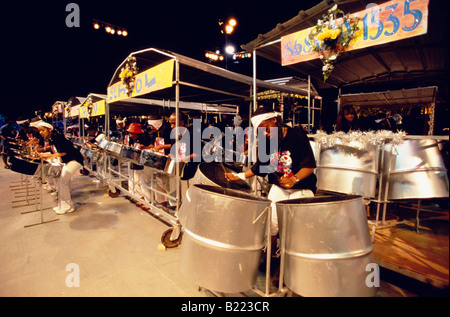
[{"x1": 37, "y1": 121, "x2": 83, "y2": 214}]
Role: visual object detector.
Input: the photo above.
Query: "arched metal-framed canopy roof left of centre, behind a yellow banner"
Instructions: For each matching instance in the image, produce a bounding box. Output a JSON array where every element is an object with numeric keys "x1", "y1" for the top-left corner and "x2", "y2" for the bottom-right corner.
[{"x1": 108, "y1": 48, "x2": 313, "y2": 107}]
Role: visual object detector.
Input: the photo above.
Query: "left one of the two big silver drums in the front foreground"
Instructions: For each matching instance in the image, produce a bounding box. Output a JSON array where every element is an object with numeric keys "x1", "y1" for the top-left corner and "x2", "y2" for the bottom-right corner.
[{"x1": 179, "y1": 185, "x2": 270, "y2": 293}]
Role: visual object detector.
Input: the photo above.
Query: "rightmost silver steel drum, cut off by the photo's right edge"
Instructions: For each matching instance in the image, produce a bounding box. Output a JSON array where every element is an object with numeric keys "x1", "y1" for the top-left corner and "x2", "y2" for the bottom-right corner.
[{"x1": 383, "y1": 140, "x2": 449, "y2": 199}]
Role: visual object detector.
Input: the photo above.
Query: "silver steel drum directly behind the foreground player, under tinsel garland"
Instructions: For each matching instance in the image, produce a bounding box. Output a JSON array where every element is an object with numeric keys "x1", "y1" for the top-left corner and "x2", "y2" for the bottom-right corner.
[{"x1": 316, "y1": 144, "x2": 379, "y2": 197}]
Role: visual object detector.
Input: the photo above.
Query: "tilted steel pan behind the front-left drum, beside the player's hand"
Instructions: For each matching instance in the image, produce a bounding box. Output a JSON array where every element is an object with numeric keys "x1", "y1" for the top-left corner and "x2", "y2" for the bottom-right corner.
[{"x1": 192, "y1": 163, "x2": 251, "y2": 192}]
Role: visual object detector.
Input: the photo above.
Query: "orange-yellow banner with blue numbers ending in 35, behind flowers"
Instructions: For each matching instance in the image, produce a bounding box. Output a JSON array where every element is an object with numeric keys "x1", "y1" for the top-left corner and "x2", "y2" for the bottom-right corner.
[{"x1": 281, "y1": 0, "x2": 429, "y2": 66}]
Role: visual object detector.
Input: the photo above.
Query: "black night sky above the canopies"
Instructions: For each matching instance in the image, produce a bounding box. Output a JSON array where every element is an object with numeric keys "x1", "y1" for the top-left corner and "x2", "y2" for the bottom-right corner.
[{"x1": 0, "y1": 0, "x2": 320, "y2": 116}]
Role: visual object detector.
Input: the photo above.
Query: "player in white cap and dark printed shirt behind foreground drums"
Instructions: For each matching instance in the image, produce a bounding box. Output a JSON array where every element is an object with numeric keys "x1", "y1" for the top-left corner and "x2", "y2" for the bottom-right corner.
[{"x1": 225, "y1": 106, "x2": 317, "y2": 239}]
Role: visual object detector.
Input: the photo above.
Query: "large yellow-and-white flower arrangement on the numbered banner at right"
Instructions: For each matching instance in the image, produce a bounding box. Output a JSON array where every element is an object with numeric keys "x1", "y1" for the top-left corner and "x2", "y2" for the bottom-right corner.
[{"x1": 308, "y1": 5, "x2": 360, "y2": 81}]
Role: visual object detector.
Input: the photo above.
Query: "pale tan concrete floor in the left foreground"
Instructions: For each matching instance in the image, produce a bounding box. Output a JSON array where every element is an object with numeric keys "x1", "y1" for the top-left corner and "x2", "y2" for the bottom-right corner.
[{"x1": 0, "y1": 166, "x2": 444, "y2": 297}]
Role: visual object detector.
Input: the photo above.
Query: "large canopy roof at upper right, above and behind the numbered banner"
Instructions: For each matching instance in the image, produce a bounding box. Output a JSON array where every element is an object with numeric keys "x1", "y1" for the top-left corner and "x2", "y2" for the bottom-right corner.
[{"x1": 241, "y1": 0, "x2": 449, "y2": 89}]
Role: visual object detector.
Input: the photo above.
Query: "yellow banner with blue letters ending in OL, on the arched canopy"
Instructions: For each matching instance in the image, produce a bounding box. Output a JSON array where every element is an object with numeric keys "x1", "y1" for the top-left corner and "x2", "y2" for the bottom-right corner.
[{"x1": 108, "y1": 59, "x2": 175, "y2": 103}]
